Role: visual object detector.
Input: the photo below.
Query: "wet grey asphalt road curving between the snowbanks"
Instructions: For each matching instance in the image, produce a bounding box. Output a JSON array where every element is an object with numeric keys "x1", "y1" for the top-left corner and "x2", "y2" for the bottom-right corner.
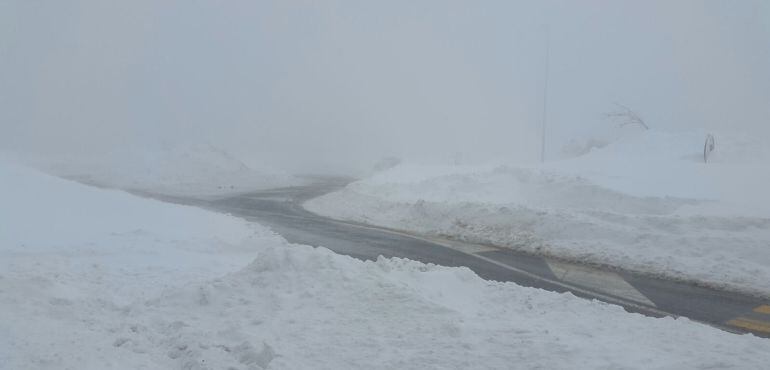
[{"x1": 143, "y1": 178, "x2": 770, "y2": 338}]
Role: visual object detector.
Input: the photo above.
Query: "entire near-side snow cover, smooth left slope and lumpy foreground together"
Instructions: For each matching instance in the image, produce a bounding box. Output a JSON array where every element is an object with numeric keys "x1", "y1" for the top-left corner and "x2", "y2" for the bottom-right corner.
[{"x1": 0, "y1": 154, "x2": 770, "y2": 370}]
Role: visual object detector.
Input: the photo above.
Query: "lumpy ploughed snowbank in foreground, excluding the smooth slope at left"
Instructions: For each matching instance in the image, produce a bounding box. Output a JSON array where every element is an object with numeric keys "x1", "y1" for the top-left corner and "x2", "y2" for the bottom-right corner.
[{"x1": 115, "y1": 247, "x2": 770, "y2": 369}]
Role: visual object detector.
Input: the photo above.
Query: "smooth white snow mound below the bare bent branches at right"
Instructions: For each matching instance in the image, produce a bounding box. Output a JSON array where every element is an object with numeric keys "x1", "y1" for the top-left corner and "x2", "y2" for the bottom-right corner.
[{"x1": 556, "y1": 131, "x2": 770, "y2": 207}]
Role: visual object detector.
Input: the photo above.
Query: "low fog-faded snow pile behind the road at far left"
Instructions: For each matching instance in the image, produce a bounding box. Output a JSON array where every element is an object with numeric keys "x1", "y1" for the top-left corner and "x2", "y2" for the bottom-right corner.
[{"x1": 21, "y1": 143, "x2": 299, "y2": 196}]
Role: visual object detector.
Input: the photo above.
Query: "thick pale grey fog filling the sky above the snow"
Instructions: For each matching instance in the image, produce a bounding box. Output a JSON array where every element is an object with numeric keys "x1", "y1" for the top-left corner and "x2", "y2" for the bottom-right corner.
[{"x1": 0, "y1": 0, "x2": 770, "y2": 172}]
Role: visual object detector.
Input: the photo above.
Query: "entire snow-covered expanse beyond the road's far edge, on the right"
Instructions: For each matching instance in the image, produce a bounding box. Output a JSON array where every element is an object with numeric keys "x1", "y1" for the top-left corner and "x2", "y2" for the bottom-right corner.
[{"x1": 306, "y1": 131, "x2": 770, "y2": 296}]
